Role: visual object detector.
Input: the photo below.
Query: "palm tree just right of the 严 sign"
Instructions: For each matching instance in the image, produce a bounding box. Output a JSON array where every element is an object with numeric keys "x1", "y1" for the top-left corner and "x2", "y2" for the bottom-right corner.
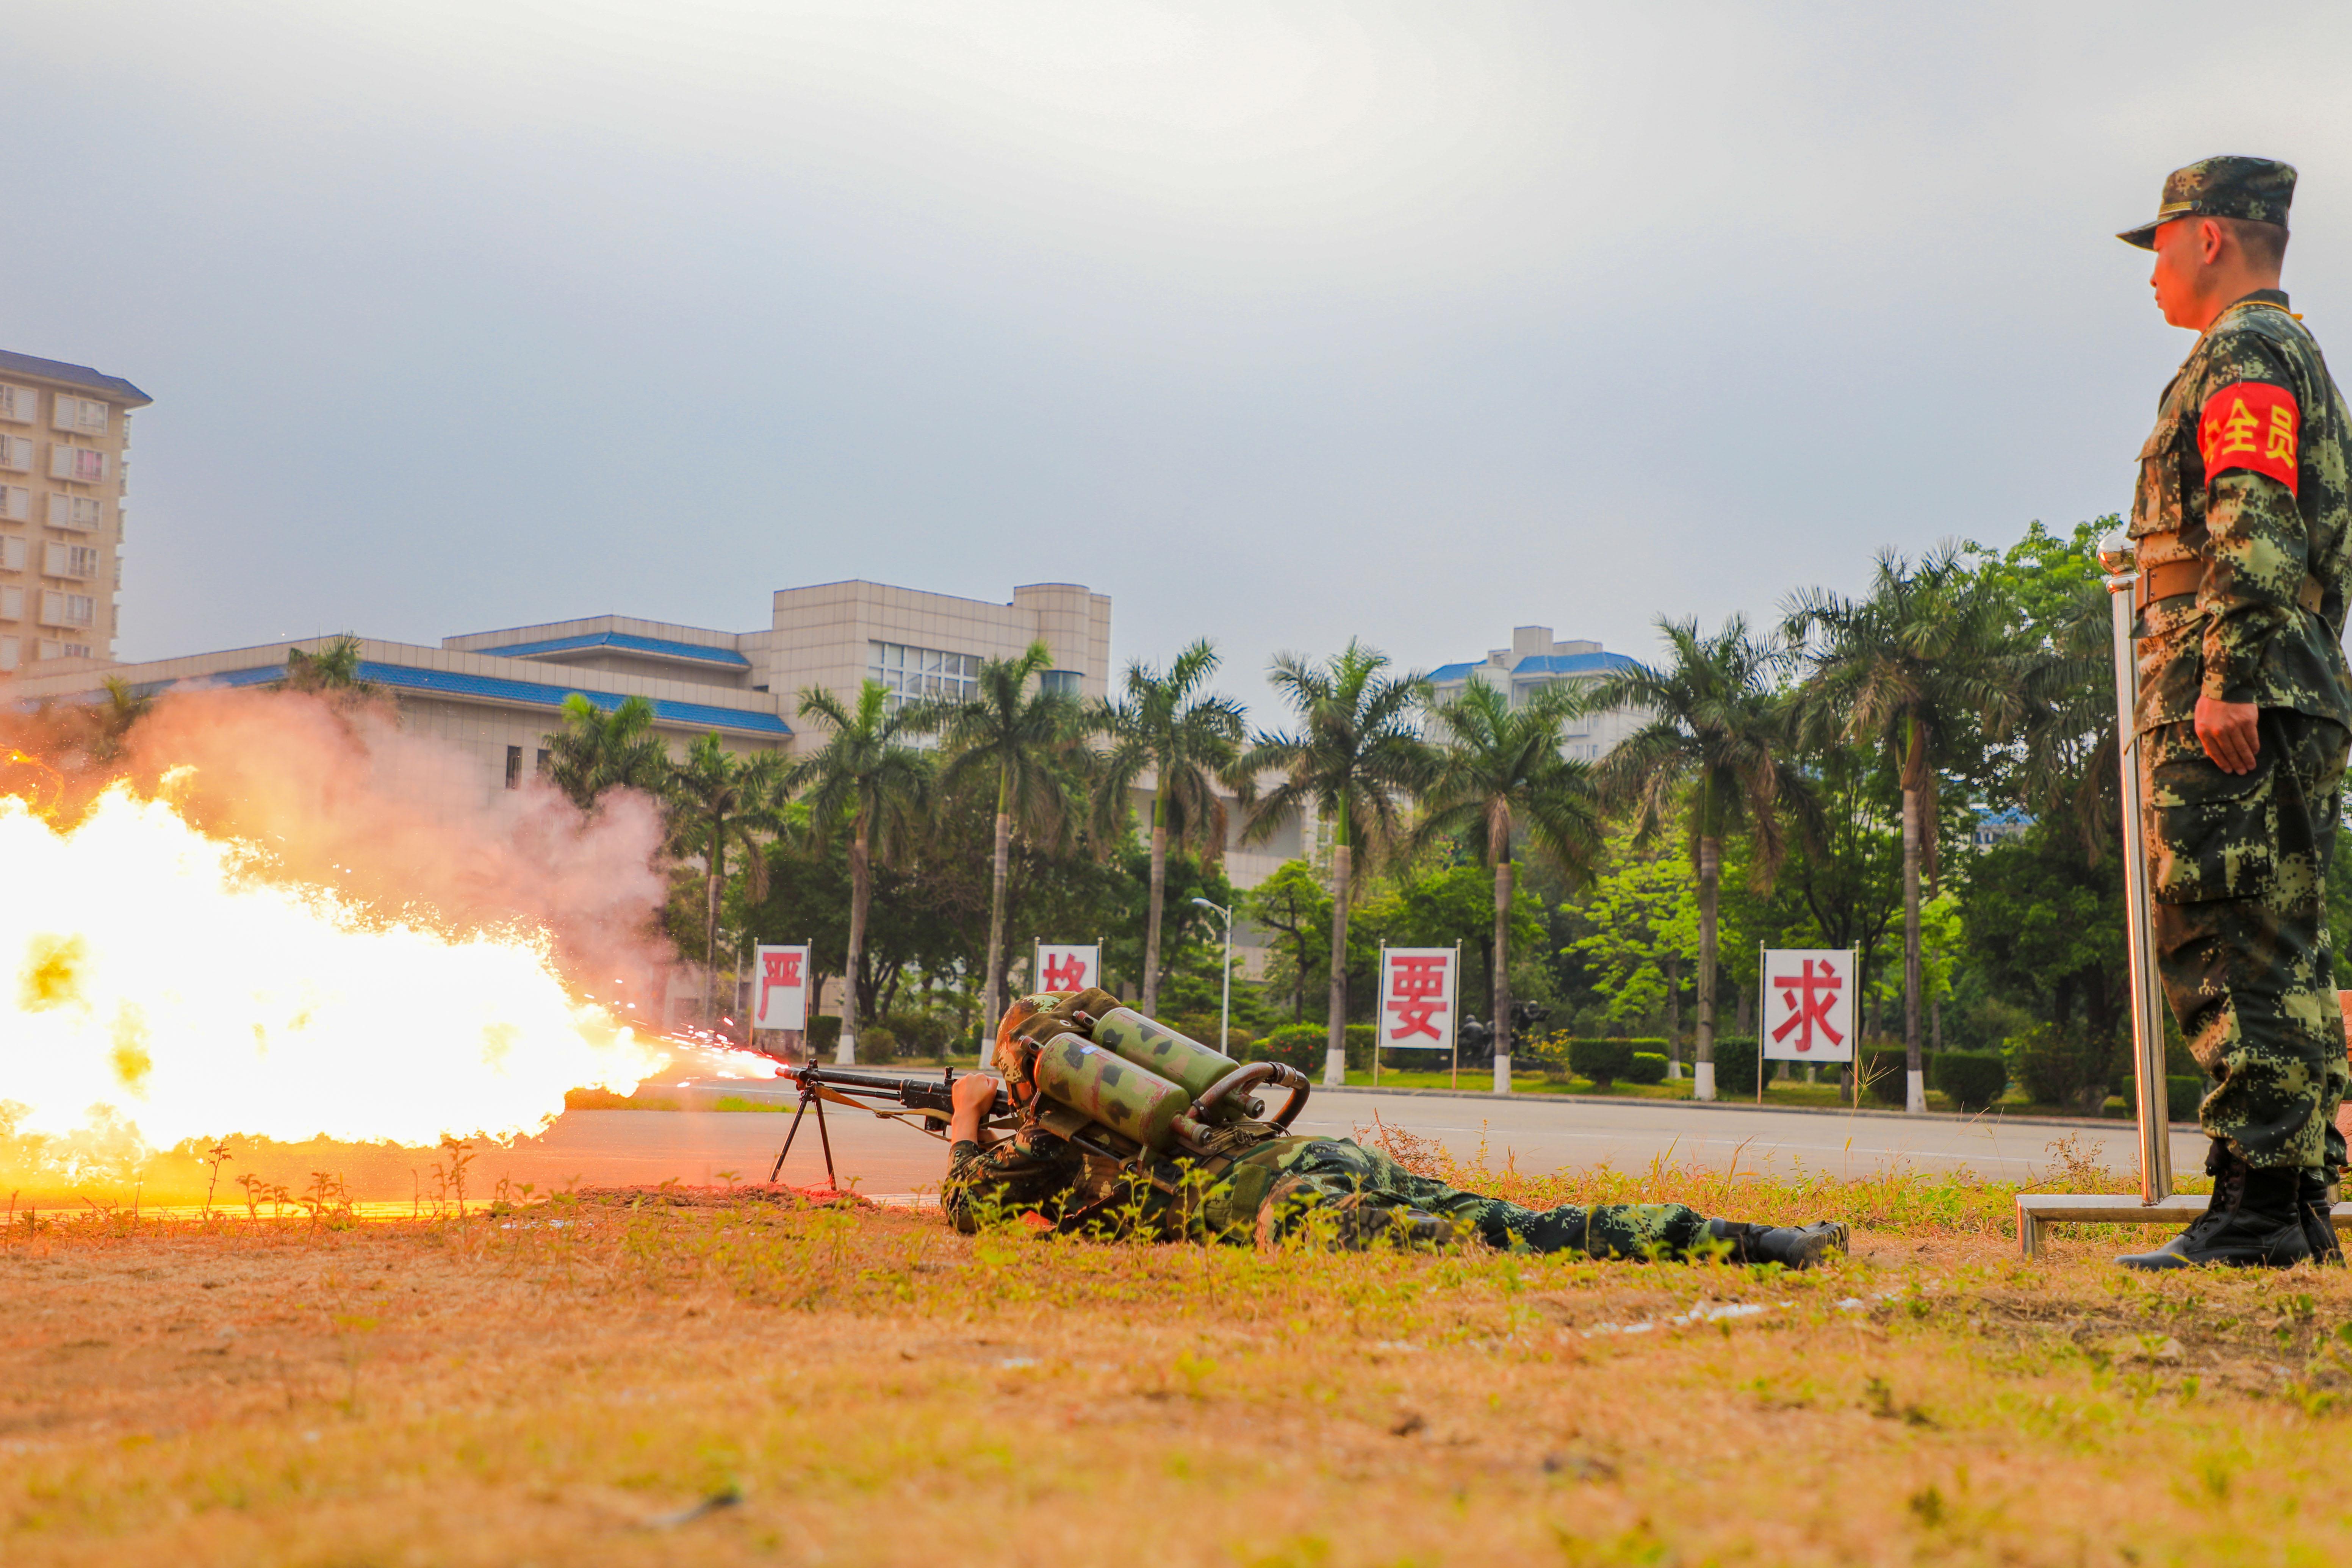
[{"x1": 786, "y1": 679, "x2": 931, "y2": 1063}]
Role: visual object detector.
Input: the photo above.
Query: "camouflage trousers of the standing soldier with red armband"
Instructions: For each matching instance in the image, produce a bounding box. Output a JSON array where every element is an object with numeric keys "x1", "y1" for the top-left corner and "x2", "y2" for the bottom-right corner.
[{"x1": 2140, "y1": 707, "x2": 2347, "y2": 1178}]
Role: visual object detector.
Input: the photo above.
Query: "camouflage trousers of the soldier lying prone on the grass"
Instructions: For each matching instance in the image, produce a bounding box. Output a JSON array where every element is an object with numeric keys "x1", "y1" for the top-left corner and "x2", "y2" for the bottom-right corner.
[{"x1": 1258, "y1": 1140, "x2": 1722, "y2": 1258}]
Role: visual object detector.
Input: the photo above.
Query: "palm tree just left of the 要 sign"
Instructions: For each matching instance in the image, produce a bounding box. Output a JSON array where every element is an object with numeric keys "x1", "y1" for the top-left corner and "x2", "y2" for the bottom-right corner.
[{"x1": 1237, "y1": 642, "x2": 1437, "y2": 1084}]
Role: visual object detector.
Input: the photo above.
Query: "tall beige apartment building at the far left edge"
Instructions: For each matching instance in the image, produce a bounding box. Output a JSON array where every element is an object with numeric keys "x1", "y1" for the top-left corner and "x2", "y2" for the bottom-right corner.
[{"x1": 0, "y1": 350, "x2": 153, "y2": 670}]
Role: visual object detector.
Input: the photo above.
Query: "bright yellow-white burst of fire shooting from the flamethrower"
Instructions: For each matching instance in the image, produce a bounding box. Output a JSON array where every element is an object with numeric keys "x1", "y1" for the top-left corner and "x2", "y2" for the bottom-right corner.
[{"x1": 0, "y1": 778, "x2": 670, "y2": 1150}]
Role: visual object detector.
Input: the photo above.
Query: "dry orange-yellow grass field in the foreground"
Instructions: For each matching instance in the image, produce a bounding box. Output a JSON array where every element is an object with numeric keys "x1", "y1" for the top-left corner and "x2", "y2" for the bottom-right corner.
[{"x1": 0, "y1": 1133, "x2": 2352, "y2": 1568}]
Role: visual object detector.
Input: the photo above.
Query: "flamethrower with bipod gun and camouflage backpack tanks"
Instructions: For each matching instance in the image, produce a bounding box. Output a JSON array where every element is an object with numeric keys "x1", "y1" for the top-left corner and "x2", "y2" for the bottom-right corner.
[{"x1": 769, "y1": 1006, "x2": 1310, "y2": 1185}]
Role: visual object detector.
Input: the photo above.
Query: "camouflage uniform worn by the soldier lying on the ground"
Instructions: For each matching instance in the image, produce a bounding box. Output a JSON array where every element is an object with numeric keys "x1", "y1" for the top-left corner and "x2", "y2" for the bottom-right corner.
[{"x1": 943, "y1": 1124, "x2": 1724, "y2": 1258}]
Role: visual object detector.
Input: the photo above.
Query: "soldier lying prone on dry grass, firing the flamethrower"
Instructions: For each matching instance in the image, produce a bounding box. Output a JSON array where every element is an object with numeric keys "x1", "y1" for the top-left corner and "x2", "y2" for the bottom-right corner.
[{"x1": 943, "y1": 990, "x2": 1846, "y2": 1269}]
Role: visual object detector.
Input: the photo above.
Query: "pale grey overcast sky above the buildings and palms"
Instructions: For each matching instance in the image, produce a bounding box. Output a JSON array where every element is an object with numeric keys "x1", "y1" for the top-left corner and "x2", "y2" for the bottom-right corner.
[{"x1": 18, "y1": 0, "x2": 2352, "y2": 717}]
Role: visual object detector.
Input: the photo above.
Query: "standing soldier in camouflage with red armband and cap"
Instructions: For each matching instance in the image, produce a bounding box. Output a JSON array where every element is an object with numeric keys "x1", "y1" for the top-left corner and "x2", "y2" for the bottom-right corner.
[{"x1": 2119, "y1": 158, "x2": 2352, "y2": 1269}]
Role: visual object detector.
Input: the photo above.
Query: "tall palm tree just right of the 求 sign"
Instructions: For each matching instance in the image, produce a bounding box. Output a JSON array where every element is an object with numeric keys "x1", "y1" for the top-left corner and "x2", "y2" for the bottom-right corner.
[{"x1": 1787, "y1": 545, "x2": 2027, "y2": 1112}]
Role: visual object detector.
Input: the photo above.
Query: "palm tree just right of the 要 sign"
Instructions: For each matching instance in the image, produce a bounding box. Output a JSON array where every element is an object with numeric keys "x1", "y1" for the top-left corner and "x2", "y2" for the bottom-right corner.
[{"x1": 1413, "y1": 679, "x2": 1599, "y2": 1093}]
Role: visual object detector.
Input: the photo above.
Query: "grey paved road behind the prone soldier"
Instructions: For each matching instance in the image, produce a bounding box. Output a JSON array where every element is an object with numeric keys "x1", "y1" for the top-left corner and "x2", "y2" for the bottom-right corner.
[{"x1": 171, "y1": 1084, "x2": 2204, "y2": 1201}]
